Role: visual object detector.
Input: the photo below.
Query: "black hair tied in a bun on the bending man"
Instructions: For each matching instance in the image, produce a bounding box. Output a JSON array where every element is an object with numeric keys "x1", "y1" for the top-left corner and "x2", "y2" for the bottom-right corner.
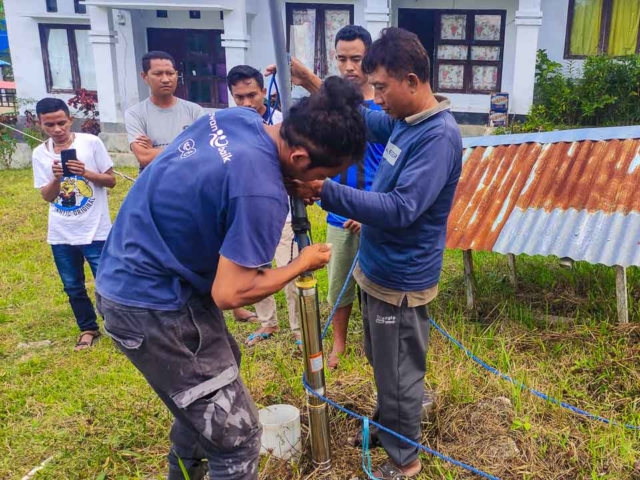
[{"x1": 280, "y1": 77, "x2": 366, "y2": 168}]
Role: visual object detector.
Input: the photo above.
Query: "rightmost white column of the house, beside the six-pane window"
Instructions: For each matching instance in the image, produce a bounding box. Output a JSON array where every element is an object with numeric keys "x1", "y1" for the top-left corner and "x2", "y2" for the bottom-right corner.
[{"x1": 511, "y1": 0, "x2": 542, "y2": 115}]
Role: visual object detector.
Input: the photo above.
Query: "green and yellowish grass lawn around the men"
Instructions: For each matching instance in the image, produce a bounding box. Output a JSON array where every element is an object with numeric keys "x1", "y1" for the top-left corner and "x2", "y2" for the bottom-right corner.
[{"x1": 0, "y1": 169, "x2": 640, "y2": 480}]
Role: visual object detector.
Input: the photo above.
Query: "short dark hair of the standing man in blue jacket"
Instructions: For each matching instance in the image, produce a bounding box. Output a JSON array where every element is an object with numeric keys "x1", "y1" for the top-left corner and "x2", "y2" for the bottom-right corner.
[{"x1": 362, "y1": 27, "x2": 431, "y2": 83}]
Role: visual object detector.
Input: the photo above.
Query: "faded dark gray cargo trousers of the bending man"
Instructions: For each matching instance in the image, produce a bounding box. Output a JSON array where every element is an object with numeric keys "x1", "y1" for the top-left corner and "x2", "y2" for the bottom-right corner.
[{"x1": 96, "y1": 295, "x2": 262, "y2": 480}]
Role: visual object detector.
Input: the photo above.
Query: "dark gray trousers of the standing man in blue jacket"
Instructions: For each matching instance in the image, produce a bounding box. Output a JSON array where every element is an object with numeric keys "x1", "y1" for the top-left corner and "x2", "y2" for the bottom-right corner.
[{"x1": 362, "y1": 292, "x2": 429, "y2": 466}]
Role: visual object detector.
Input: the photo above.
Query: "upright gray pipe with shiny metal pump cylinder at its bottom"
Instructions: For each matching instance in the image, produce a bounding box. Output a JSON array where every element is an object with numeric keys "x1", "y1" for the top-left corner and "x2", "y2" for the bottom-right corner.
[{"x1": 269, "y1": 0, "x2": 331, "y2": 471}]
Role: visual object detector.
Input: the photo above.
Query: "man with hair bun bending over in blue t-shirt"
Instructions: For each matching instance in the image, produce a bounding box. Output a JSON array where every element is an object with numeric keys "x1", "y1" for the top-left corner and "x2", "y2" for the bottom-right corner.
[{"x1": 96, "y1": 77, "x2": 365, "y2": 480}]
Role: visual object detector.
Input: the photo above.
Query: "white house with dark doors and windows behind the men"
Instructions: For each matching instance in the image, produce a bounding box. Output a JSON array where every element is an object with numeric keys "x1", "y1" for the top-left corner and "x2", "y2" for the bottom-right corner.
[{"x1": 4, "y1": 0, "x2": 640, "y2": 132}]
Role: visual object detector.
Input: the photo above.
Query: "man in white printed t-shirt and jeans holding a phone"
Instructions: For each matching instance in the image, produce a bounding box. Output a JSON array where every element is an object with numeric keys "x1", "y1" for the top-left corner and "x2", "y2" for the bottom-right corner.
[{"x1": 33, "y1": 98, "x2": 116, "y2": 351}]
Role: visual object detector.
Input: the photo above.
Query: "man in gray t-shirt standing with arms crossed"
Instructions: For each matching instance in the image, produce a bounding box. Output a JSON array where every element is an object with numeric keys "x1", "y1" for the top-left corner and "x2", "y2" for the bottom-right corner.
[{"x1": 124, "y1": 51, "x2": 204, "y2": 171}]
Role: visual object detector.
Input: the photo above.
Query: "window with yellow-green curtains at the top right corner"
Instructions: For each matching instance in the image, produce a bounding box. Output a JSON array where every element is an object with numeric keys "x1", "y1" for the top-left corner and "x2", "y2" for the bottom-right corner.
[{"x1": 565, "y1": 0, "x2": 640, "y2": 58}]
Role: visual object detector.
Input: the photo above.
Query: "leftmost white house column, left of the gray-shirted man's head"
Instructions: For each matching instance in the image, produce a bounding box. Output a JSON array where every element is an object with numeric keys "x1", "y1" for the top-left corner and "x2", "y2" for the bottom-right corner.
[{"x1": 87, "y1": 6, "x2": 123, "y2": 131}]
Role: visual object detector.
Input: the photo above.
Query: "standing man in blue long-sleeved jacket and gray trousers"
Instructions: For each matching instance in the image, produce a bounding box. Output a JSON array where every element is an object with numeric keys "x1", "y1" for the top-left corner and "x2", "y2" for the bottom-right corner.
[{"x1": 282, "y1": 28, "x2": 462, "y2": 480}]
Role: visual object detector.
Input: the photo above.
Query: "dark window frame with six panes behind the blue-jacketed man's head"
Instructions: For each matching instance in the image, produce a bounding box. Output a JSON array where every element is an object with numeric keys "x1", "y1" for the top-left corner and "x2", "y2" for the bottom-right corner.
[{"x1": 431, "y1": 9, "x2": 507, "y2": 95}]
